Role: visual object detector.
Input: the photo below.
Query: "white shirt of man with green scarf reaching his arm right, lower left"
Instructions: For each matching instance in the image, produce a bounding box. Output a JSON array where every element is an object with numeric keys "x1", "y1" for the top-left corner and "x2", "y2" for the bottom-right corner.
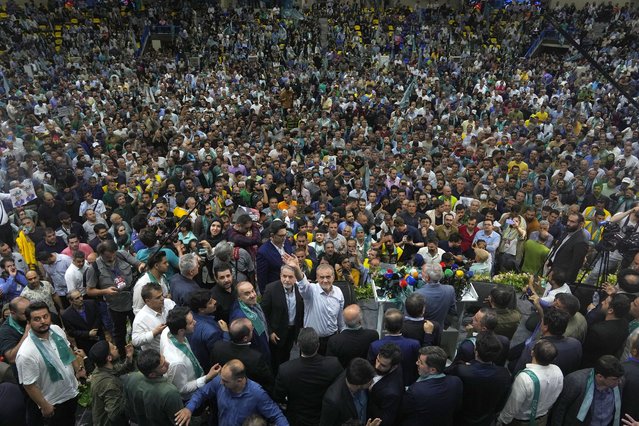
[{"x1": 160, "y1": 326, "x2": 206, "y2": 400}]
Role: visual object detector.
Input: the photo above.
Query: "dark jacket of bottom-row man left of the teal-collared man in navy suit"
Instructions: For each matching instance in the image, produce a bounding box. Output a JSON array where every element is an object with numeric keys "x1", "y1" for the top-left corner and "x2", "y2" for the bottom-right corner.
[{"x1": 367, "y1": 365, "x2": 402, "y2": 426}]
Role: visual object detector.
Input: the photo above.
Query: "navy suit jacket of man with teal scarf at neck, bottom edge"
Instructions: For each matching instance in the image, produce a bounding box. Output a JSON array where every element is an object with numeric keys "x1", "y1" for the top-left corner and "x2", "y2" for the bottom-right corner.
[{"x1": 400, "y1": 376, "x2": 463, "y2": 426}]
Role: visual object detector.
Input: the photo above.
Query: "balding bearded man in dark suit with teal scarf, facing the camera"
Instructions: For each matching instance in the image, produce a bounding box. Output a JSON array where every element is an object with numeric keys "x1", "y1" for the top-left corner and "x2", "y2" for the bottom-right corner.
[{"x1": 229, "y1": 281, "x2": 271, "y2": 363}]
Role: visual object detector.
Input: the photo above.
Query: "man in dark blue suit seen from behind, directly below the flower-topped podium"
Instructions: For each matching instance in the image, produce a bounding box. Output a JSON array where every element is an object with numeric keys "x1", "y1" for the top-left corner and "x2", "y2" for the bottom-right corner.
[{"x1": 368, "y1": 309, "x2": 421, "y2": 385}]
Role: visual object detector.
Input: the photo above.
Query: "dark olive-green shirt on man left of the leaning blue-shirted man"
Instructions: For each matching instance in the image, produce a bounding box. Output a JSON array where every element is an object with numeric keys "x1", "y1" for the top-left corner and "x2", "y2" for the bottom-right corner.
[{"x1": 123, "y1": 372, "x2": 184, "y2": 426}]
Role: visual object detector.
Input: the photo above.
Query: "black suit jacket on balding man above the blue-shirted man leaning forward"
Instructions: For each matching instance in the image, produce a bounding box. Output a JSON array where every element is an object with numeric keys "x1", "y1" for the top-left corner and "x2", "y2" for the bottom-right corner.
[{"x1": 211, "y1": 340, "x2": 275, "y2": 392}]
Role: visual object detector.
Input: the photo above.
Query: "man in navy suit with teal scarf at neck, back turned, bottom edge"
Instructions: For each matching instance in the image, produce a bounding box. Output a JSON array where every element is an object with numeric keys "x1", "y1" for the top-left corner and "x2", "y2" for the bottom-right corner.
[{"x1": 400, "y1": 346, "x2": 463, "y2": 426}]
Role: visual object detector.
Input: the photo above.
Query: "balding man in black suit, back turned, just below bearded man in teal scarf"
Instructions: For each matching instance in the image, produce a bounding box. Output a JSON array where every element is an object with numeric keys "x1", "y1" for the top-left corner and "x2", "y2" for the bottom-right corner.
[{"x1": 211, "y1": 318, "x2": 274, "y2": 393}]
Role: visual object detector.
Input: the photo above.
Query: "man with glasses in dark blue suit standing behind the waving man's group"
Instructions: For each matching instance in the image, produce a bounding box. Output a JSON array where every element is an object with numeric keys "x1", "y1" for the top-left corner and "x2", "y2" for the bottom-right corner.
[{"x1": 255, "y1": 219, "x2": 293, "y2": 294}]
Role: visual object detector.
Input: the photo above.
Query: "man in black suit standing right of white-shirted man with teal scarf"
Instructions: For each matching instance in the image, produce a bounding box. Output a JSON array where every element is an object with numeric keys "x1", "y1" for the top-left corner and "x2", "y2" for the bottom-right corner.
[{"x1": 62, "y1": 290, "x2": 104, "y2": 354}]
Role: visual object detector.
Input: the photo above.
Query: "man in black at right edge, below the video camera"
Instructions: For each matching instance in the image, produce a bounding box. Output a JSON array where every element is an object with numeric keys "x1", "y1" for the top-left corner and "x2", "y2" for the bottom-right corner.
[{"x1": 581, "y1": 294, "x2": 630, "y2": 368}]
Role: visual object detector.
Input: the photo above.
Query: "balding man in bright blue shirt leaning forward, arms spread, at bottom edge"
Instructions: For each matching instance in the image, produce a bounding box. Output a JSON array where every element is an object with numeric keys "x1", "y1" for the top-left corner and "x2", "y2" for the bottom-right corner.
[{"x1": 175, "y1": 359, "x2": 288, "y2": 426}]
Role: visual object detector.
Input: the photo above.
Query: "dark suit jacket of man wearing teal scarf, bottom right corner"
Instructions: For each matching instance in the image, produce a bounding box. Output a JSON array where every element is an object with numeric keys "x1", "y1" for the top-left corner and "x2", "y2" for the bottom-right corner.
[{"x1": 550, "y1": 368, "x2": 624, "y2": 426}]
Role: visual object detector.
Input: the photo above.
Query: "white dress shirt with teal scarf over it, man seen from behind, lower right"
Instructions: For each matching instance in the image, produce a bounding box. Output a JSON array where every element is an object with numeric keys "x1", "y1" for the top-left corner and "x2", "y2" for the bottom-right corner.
[{"x1": 499, "y1": 364, "x2": 564, "y2": 424}]
